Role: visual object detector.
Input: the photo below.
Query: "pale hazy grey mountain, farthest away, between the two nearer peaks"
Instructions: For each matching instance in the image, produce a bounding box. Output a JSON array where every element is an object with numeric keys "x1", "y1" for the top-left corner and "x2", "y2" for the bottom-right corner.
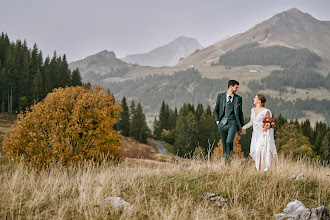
[{"x1": 121, "y1": 37, "x2": 203, "y2": 67}]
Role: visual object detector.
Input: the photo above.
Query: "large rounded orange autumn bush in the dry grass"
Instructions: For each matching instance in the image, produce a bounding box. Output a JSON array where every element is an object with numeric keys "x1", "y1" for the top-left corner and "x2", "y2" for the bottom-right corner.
[{"x1": 3, "y1": 86, "x2": 122, "y2": 168}]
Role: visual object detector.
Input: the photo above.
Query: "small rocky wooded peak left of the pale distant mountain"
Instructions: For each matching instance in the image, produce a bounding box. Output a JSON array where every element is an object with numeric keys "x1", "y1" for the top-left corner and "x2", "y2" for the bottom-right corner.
[{"x1": 69, "y1": 50, "x2": 134, "y2": 83}]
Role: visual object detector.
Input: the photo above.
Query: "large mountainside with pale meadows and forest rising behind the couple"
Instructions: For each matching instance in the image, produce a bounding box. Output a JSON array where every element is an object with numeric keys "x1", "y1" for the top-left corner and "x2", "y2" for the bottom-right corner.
[{"x1": 69, "y1": 9, "x2": 330, "y2": 126}]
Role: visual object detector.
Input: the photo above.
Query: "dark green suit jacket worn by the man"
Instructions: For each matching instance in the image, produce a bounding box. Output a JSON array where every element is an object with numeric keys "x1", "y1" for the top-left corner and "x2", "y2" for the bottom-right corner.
[{"x1": 214, "y1": 92, "x2": 245, "y2": 128}]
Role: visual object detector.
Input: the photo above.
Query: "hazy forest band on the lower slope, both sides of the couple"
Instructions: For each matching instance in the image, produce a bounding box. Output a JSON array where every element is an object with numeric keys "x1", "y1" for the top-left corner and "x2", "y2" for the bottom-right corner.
[{"x1": 104, "y1": 69, "x2": 330, "y2": 126}]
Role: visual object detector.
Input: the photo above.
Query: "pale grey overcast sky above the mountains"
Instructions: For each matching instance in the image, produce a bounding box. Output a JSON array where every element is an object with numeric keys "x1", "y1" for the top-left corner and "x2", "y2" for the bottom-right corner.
[{"x1": 0, "y1": 0, "x2": 330, "y2": 62}]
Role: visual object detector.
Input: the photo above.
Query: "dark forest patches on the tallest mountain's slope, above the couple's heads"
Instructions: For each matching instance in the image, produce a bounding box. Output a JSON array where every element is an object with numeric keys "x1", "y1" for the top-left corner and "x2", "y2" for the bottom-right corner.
[{"x1": 216, "y1": 42, "x2": 330, "y2": 91}]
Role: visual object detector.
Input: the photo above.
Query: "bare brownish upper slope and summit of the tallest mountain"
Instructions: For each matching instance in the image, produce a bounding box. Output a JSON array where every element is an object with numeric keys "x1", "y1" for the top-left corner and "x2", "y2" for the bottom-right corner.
[{"x1": 177, "y1": 8, "x2": 330, "y2": 67}]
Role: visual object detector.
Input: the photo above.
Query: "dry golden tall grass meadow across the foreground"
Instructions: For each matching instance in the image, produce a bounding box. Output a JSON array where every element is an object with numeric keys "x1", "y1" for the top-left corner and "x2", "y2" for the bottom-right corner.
[{"x1": 0, "y1": 158, "x2": 330, "y2": 219}]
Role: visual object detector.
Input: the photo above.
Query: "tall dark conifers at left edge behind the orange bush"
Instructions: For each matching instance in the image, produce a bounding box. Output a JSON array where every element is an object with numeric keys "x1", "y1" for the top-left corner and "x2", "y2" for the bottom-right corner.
[{"x1": 0, "y1": 33, "x2": 82, "y2": 113}]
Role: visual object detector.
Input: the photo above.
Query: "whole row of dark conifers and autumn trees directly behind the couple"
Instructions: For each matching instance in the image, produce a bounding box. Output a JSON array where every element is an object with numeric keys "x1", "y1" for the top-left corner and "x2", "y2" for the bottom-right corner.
[{"x1": 117, "y1": 97, "x2": 330, "y2": 163}]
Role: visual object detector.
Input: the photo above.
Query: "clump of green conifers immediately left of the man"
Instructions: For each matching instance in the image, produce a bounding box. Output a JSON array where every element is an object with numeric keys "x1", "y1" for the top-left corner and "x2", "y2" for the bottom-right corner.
[{"x1": 154, "y1": 101, "x2": 219, "y2": 156}]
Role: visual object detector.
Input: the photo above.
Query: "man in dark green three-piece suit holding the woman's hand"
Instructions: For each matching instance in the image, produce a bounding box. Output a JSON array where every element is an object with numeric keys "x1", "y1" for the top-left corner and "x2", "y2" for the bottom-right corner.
[{"x1": 214, "y1": 80, "x2": 245, "y2": 169}]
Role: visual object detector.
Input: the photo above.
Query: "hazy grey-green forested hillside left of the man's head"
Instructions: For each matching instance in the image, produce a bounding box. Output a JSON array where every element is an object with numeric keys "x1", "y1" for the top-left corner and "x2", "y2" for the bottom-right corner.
[{"x1": 103, "y1": 68, "x2": 229, "y2": 112}]
